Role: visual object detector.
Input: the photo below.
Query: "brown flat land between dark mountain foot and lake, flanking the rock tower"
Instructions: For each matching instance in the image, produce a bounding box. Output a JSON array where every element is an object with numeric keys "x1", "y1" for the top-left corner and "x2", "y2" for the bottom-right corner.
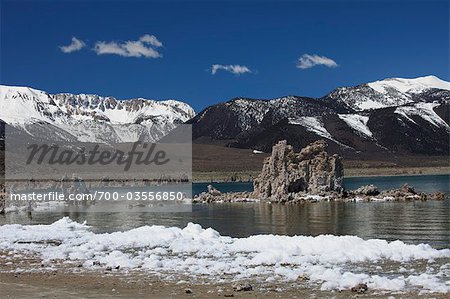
[{"x1": 192, "y1": 144, "x2": 450, "y2": 182}]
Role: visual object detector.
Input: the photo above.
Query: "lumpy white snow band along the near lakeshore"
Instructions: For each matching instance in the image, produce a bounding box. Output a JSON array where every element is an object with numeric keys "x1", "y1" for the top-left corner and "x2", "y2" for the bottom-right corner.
[{"x1": 0, "y1": 217, "x2": 450, "y2": 293}]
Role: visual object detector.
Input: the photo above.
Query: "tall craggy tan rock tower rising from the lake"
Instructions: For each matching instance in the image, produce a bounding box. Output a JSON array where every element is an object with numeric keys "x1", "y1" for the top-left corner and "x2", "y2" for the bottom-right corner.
[{"x1": 254, "y1": 140, "x2": 344, "y2": 201}]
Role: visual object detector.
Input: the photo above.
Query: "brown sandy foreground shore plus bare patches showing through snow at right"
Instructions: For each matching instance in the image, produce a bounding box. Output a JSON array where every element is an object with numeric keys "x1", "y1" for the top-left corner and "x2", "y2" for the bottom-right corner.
[{"x1": 0, "y1": 243, "x2": 448, "y2": 299}]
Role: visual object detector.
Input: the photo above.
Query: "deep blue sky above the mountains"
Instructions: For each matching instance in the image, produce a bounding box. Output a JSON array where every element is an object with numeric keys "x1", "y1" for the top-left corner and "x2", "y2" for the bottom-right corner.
[{"x1": 0, "y1": 0, "x2": 449, "y2": 111}]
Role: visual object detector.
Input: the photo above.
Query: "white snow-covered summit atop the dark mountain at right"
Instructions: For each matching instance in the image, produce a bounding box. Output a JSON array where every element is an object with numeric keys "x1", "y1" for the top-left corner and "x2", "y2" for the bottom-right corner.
[{"x1": 326, "y1": 76, "x2": 450, "y2": 111}]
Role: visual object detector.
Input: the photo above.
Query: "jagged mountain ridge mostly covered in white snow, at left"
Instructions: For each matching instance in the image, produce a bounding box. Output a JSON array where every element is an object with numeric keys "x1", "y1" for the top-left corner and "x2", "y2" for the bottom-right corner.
[{"x1": 0, "y1": 86, "x2": 195, "y2": 143}]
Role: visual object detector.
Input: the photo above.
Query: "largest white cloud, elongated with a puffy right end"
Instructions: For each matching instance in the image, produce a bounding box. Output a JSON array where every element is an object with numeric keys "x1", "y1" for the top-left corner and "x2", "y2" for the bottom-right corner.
[{"x1": 93, "y1": 34, "x2": 163, "y2": 58}]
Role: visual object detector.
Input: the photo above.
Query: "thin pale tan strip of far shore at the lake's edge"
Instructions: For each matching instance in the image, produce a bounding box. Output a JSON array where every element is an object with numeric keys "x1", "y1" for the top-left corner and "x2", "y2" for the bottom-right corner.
[{"x1": 193, "y1": 166, "x2": 450, "y2": 183}]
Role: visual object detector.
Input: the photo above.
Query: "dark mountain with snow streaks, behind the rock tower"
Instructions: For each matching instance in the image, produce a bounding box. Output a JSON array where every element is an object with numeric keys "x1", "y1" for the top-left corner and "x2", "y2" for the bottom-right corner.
[{"x1": 189, "y1": 76, "x2": 450, "y2": 154}]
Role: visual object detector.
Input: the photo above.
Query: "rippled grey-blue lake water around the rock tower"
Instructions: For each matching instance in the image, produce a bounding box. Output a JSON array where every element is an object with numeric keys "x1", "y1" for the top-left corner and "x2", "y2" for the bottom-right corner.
[{"x1": 0, "y1": 175, "x2": 450, "y2": 248}]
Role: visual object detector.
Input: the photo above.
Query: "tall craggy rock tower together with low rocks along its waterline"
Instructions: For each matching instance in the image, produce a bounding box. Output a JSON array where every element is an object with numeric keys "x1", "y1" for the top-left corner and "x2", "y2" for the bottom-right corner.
[{"x1": 193, "y1": 140, "x2": 446, "y2": 203}]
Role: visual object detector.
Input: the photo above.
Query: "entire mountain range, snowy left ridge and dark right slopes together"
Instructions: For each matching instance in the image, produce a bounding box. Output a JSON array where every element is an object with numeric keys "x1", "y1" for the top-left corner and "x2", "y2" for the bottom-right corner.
[{"x1": 0, "y1": 76, "x2": 450, "y2": 156}]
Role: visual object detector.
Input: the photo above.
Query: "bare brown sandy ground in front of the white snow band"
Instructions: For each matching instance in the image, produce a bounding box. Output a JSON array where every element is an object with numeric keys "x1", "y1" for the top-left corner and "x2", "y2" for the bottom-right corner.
[{"x1": 0, "y1": 252, "x2": 448, "y2": 299}]
